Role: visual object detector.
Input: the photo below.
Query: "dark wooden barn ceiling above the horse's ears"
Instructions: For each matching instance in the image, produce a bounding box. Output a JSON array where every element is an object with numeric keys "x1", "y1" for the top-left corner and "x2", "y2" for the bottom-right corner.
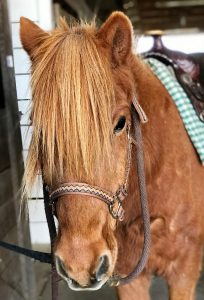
[{"x1": 54, "y1": 0, "x2": 204, "y2": 33}]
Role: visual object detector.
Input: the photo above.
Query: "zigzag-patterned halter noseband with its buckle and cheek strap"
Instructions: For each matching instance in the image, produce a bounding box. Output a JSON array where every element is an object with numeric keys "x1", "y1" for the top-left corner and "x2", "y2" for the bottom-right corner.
[{"x1": 50, "y1": 125, "x2": 136, "y2": 221}]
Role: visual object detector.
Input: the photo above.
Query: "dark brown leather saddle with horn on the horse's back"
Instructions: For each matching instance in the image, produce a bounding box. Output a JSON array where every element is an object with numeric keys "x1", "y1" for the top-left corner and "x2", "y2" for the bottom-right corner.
[{"x1": 142, "y1": 31, "x2": 204, "y2": 122}]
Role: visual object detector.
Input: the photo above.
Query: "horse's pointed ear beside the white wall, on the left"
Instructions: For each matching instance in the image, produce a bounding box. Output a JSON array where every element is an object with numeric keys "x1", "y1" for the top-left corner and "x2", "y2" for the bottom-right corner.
[{"x1": 20, "y1": 17, "x2": 49, "y2": 56}]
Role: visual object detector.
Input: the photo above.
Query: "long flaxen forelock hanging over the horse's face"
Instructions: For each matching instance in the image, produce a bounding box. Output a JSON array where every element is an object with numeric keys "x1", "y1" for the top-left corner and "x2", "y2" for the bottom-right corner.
[{"x1": 24, "y1": 20, "x2": 115, "y2": 193}]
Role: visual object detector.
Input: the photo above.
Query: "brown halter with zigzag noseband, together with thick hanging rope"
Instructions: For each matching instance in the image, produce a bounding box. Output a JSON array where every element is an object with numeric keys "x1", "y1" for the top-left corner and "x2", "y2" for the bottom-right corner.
[{"x1": 47, "y1": 98, "x2": 151, "y2": 288}]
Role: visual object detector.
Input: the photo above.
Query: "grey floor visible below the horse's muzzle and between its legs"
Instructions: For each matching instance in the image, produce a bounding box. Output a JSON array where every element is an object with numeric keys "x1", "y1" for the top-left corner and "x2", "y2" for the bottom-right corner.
[{"x1": 35, "y1": 255, "x2": 204, "y2": 300}]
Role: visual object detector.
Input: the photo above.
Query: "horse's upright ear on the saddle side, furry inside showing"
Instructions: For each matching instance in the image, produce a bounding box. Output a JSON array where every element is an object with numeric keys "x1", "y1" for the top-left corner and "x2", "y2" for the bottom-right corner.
[{"x1": 97, "y1": 12, "x2": 133, "y2": 65}]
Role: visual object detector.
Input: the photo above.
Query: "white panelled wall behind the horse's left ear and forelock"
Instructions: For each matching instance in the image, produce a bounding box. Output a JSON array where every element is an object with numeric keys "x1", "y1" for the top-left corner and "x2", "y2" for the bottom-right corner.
[{"x1": 8, "y1": 0, "x2": 53, "y2": 244}]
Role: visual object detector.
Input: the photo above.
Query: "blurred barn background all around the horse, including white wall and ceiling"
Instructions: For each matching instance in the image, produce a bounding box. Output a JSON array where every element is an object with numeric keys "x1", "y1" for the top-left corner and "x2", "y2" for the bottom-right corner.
[{"x1": 0, "y1": 0, "x2": 204, "y2": 300}]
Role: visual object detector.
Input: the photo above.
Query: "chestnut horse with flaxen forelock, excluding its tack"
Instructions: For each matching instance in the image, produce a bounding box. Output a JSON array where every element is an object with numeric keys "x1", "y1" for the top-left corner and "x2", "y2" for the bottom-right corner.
[{"x1": 21, "y1": 12, "x2": 204, "y2": 300}]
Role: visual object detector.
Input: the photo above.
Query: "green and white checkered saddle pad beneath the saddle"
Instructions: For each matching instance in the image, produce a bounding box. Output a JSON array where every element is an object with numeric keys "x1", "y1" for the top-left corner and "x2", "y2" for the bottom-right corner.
[{"x1": 145, "y1": 58, "x2": 204, "y2": 165}]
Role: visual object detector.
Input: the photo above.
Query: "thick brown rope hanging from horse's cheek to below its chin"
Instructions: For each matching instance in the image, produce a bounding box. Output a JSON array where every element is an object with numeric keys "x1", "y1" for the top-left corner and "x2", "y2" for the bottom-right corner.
[{"x1": 111, "y1": 107, "x2": 151, "y2": 286}]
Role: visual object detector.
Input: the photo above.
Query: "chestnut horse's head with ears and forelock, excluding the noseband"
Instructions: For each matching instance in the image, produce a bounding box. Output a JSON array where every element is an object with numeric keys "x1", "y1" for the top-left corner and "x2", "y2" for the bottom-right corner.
[{"x1": 21, "y1": 12, "x2": 138, "y2": 289}]
